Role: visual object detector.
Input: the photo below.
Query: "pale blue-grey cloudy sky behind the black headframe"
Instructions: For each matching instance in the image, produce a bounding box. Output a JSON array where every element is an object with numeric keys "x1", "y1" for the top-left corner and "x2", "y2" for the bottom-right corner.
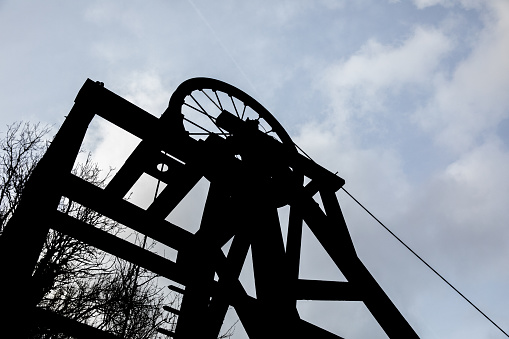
[{"x1": 0, "y1": 0, "x2": 509, "y2": 339}]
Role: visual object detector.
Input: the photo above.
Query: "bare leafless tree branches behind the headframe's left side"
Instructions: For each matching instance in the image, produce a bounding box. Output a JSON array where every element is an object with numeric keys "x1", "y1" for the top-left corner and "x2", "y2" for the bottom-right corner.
[{"x1": 0, "y1": 122, "x2": 183, "y2": 338}]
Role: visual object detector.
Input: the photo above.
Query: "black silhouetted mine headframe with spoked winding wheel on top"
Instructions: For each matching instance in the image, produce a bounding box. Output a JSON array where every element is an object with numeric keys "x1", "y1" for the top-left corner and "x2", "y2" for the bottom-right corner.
[{"x1": 0, "y1": 78, "x2": 418, "y2": 339}]
